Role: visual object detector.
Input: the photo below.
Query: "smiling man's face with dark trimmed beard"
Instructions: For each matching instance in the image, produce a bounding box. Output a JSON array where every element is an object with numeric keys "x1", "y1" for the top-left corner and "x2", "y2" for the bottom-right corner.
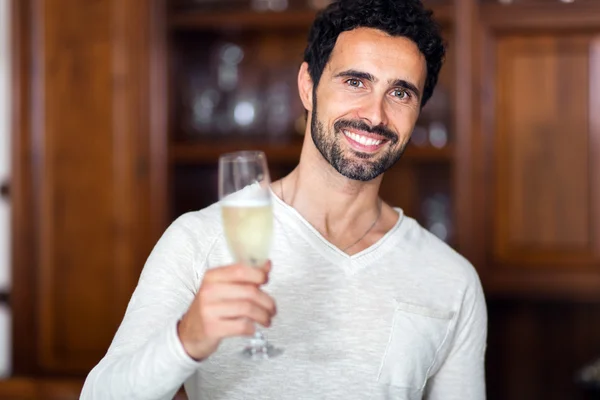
[{"x1": 309, "y1": 28, "x2": 427, "y2": 181}]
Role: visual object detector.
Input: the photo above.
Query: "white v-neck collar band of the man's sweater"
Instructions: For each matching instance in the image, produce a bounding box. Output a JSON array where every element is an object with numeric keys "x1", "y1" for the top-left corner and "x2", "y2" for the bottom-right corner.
[{"x1": 271, "y1": 190, "x2": 406, "y2": 273}]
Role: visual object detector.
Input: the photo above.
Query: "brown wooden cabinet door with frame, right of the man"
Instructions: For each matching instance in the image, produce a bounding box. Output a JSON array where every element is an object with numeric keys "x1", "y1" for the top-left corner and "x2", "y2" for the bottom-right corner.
[{"x1": 474, "y1": 4, "x2": 600, "y2": 297}]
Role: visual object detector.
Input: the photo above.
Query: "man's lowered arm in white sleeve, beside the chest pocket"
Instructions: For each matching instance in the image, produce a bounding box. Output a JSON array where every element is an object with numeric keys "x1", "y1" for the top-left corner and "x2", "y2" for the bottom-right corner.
[{"x1": 425, "y1": 272, "x2": 487, "y2": 400}]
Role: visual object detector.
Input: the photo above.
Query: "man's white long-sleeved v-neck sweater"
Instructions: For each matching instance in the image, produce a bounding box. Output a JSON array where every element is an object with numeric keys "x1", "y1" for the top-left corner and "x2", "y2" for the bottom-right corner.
[{"x1": 81, "y1": 195, "x2": 487, "y2": 400}]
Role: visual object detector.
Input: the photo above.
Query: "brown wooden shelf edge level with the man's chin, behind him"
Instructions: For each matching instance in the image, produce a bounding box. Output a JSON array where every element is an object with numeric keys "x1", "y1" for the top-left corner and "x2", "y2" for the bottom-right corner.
[{"x1": 169, "y1": 140, "x2": 454, "y2": 165}]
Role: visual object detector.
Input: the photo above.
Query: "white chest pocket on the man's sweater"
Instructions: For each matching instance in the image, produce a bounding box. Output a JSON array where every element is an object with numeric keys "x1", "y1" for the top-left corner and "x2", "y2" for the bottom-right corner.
[{"x1": 378, "y1": 301, "x2": 454, "y2": 390}]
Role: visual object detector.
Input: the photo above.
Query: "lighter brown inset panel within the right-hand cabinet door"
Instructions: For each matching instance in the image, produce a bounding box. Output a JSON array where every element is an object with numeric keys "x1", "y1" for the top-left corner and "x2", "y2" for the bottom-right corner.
[{"x1": 494, "y1": 34, "x2": 600, "y2": 268}]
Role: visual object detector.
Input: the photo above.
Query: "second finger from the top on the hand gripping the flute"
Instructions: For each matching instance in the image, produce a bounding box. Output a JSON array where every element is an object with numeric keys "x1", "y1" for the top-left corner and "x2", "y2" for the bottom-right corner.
[{"x1": 200, "y1": 282, "x2": 276, "y2": 315}]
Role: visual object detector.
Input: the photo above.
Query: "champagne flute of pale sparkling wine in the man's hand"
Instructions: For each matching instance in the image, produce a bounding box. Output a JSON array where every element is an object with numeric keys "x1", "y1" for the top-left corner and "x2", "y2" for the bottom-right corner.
[{"x1": 219, "y1": 151, "x2": 282, "y2": 359}]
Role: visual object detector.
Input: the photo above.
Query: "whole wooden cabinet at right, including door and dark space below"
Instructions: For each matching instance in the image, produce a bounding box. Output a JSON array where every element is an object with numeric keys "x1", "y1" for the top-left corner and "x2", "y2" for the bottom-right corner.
[{"x1": 472, "y1": 0, "x2": 600, "y2": 400}]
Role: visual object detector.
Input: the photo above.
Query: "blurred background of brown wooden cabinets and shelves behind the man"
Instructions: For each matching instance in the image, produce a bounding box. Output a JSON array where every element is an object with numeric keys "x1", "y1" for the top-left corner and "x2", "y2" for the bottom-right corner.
[{"x1": 0, "y1": 0, "x2": 600, "y2": 400}]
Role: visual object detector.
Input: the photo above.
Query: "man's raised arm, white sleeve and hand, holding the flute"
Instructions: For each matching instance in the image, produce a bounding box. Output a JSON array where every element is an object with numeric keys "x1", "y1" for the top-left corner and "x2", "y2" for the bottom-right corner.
[{"x1": 81, "y1": 212, "x2": 275, "y2": 400}]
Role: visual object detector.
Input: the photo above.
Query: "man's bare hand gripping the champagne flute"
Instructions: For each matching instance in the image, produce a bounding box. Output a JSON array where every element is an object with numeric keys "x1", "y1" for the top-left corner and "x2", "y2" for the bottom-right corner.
[{"x1": 177, "y1": 262, "x2": 276, "y2": 360}]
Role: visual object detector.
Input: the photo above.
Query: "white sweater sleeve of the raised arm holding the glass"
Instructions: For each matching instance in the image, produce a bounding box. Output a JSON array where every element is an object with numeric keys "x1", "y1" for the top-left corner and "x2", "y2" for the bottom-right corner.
[{"x1": 81, "y1": 216, "x2": 211, "y2": 400}]
